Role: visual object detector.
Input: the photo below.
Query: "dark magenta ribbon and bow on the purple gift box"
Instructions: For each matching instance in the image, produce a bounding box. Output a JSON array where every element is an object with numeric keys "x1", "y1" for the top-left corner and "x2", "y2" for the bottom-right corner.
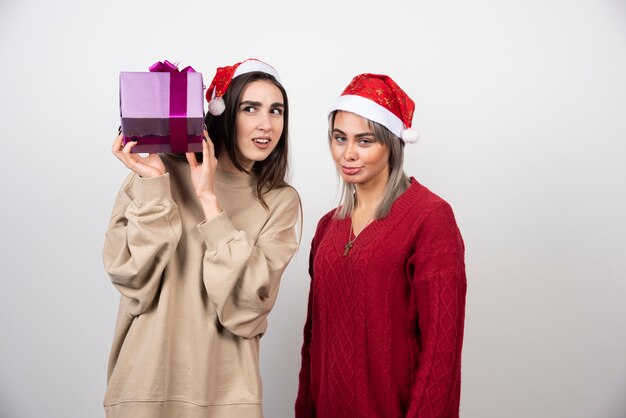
[{"x1": 150, "y1": 60, "x2": 195, "y2": 153}]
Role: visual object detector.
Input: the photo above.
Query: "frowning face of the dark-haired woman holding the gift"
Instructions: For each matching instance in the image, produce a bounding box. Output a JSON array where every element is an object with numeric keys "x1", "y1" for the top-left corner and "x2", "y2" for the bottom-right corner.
[{"x1": 235, "y1": 80, "x2": 285, "y2": 168}]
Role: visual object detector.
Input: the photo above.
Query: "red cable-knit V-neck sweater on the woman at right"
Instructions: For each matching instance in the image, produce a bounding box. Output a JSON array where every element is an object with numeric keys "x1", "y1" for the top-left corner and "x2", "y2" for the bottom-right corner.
[{"x1": 296, "y1": 179, "x2": 467, "y2": 418}]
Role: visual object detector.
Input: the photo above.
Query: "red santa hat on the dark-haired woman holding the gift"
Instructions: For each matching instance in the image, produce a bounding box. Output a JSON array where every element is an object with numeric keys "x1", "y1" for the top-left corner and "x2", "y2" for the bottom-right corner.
[{"x1": 206, "y1": 58, "x2": 280, "y2": 116}]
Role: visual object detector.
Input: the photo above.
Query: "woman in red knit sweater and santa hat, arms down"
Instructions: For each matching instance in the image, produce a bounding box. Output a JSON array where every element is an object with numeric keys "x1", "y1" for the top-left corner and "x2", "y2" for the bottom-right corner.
[{"x1": 296, "y1": 74, "x2": 467, "y2": 418}]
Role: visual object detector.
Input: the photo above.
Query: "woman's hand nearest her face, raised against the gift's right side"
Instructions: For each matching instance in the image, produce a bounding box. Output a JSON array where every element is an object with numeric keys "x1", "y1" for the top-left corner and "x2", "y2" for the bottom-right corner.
[{"x1": 185, "y1": 131, "x2": 222, "y2": 221}]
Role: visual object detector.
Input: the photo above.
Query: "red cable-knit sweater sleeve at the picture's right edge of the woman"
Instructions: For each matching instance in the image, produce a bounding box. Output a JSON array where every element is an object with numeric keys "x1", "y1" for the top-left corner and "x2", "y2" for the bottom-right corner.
[{"x1": 407, "y1": 204, "x2": 467, "y2": 418}]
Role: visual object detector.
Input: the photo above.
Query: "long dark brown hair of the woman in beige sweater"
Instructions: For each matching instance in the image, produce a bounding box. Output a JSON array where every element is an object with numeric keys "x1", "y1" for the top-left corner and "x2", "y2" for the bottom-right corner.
[{"x1": 204, "y1": 71, "x2": 289, "y2": 208}]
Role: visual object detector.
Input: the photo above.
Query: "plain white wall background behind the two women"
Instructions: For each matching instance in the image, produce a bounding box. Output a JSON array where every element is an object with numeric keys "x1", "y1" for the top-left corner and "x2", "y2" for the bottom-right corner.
[{"x1": 0, "y1": 0, "x2": 626, "y2": 418}]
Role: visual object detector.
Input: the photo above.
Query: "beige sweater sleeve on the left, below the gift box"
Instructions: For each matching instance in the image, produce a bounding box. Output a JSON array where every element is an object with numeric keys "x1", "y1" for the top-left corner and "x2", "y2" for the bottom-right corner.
[{"x1": 102, "y1": 174, "x2": 182, "y2": 316}]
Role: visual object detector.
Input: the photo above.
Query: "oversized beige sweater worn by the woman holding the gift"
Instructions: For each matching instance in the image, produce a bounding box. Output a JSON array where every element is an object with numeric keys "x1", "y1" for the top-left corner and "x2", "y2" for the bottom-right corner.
[{"x1": 103, "y1": 155, "x2": 300, "y2": 418}]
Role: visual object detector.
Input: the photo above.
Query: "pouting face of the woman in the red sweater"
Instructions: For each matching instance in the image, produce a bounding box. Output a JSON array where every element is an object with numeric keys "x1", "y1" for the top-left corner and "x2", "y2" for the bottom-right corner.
[{"x1": 330, "y1": 111, "x2": 389, "y2": 186}]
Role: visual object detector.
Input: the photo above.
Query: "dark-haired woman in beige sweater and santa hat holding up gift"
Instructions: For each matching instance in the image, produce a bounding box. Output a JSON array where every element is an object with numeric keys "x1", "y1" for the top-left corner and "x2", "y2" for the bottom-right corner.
[{"x1": 103, "y1": 59, "x2": 300, "y2": 418}]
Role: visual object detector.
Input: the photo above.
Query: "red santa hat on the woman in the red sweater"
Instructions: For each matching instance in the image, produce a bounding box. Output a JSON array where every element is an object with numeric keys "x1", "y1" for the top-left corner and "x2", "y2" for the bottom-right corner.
[{"x1": 330, "y1": 74, "x2": 419, "y2": 143}]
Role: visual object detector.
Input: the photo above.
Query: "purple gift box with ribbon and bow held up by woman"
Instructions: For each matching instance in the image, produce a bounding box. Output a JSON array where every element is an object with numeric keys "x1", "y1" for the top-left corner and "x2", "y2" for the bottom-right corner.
[{"x1": 120, "y1": 61, "x2": 204, "y2": 153}]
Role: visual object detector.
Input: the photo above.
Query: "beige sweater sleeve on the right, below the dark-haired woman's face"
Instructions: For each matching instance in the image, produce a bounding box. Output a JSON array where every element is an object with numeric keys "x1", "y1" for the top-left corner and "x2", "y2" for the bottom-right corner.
[{"x1": 198, "y1": 187, "x2": 300, "y2": 338}]
